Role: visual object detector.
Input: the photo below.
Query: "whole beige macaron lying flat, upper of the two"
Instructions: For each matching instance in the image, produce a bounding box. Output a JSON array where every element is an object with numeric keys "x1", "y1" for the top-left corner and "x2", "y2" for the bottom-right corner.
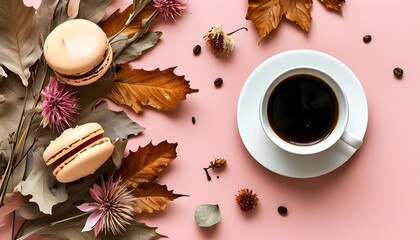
[{"x1": 44, "y1": 19, "x2": 112, "y2": 86}]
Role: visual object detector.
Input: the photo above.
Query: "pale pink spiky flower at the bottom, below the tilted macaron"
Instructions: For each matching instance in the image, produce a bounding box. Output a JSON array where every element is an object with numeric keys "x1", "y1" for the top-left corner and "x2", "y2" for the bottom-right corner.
[{"x1": 77, "y1": 177, "x2": 136, "y2": 236}]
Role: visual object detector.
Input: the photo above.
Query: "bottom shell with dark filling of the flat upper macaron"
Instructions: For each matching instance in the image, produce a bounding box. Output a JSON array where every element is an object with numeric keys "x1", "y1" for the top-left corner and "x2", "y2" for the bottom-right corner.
[{"x1": 55, "y1": 44, "x2": 113, "y2": 86}]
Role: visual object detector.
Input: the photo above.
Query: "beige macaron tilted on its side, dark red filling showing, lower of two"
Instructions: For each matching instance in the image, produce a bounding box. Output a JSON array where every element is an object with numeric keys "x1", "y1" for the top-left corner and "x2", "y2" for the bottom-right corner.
[{"x1": 43, "y1": 123, "x2": 114, "y2": 183}]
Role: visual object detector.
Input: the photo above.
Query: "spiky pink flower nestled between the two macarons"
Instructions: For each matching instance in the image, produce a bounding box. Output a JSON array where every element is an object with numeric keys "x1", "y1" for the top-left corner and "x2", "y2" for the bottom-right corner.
[{"x1": 41, "y1": 77, "x2": 79, "y2": 132}]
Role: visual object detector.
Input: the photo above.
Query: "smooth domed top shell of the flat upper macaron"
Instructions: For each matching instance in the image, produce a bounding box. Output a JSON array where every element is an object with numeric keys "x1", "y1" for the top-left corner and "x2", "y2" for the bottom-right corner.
[{"x1": 44, "y1": 19, "x2": 108, "y2": 75}]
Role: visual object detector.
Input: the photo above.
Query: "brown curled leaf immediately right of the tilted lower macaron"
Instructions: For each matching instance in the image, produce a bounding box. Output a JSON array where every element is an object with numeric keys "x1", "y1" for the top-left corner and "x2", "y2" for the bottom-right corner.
[{"x1": 117, "y1": 141, "x2": 178, "y2": 189}]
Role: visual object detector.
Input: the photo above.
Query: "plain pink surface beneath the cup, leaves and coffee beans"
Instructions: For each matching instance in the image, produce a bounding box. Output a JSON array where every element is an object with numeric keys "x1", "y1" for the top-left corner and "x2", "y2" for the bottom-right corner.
[{"x1": 2, "y1": 0, "x2": 420, "y2": 240}]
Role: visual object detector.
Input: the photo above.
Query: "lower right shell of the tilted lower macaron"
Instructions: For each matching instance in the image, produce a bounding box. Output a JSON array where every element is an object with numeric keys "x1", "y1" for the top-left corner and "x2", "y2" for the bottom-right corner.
[{"x1": 53, "y1": 138, "x2": 114, "y2": 183}]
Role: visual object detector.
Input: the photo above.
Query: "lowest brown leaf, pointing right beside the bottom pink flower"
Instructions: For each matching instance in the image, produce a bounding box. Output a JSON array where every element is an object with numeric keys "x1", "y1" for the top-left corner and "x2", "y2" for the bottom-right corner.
[{"x1": 132, "y1": 182, "x2": 186, "y2": 213}]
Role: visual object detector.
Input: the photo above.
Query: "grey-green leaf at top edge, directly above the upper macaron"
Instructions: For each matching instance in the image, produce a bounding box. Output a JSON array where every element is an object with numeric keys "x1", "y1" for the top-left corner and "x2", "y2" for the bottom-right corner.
[{"x1": 76, "y1": 0, "x2": 112, "y2": 23}]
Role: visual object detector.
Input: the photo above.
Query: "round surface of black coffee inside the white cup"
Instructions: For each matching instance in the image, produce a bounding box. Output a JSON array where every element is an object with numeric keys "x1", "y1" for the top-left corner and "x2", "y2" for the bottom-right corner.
[{"x1": 267, "y1": 74, "x2": 339, "y2": 146}]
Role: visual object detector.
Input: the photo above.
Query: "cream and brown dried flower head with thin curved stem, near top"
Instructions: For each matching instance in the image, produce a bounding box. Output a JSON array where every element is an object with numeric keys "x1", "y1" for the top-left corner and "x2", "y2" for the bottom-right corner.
[{"x1": 204, "y1": 24, "x2": 235, "y2": 57}]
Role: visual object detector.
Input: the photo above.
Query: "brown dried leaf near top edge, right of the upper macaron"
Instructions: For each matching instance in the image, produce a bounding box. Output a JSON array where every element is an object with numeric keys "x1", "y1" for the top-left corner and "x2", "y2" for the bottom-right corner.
[{"x1": 100, "y1": 3, "x2": 156, "y2": 37}]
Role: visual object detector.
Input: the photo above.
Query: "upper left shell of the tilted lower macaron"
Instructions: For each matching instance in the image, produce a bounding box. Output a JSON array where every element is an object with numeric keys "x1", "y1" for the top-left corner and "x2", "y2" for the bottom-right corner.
[{"x1": 42, "y1": 122, "x2": 104, "y2": 165}]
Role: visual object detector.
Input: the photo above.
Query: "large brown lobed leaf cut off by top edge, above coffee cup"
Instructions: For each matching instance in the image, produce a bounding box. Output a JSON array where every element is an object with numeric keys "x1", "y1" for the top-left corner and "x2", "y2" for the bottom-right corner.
[{"x1": 246, "y1": 0, "x2": 344, "y2": 40}]
